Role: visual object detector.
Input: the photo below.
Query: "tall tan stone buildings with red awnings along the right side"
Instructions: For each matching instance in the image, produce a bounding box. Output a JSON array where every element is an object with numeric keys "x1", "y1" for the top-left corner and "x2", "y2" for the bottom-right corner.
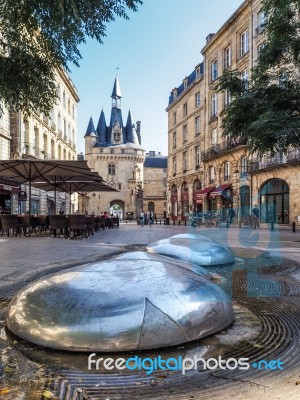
[{"x1": 167, "y1": 0, "x2": 300, "y2": 224}]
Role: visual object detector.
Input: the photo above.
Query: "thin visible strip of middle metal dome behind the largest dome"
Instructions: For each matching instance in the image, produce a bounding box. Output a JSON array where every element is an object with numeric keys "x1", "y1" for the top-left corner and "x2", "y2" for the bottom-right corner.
[{"x1": 115, "y1": 251, "x2": 213, "y2": 280}]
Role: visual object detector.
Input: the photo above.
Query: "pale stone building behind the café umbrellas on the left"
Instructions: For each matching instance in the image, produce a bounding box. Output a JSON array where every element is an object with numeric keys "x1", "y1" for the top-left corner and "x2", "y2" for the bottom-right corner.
[{"x1": 0, "y1": 71, "x2": 79, "y2": 214}]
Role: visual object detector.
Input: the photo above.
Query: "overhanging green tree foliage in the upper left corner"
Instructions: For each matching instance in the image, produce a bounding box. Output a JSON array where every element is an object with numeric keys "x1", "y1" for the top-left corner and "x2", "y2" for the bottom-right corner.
[{"x1": 0, "y1": 0, "x2": 142, "y2": 114}]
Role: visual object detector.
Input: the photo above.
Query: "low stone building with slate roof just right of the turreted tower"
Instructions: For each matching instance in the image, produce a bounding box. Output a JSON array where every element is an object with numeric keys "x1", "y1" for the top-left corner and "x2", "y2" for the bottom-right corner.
[{"x1": 143, "y1": 151, "x2": 168, "y2": 220}]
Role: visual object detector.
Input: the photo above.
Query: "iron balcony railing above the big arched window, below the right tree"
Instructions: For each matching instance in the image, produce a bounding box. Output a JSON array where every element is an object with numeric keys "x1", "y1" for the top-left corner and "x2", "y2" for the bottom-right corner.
[{"x1": 248, "y1": 148, "x2": 300, "y2": 174}]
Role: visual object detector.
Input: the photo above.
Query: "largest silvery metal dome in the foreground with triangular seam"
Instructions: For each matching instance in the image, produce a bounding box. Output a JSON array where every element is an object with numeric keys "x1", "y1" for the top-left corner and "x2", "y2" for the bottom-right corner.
[{"x1": 6, "y1": 260, "x2": 233, "y2": 352}]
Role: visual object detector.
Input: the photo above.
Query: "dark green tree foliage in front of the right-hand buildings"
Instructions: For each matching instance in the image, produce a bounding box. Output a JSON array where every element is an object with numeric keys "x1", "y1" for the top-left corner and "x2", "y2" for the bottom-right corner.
[{"x1": 219, "y1": 0, "x2": 300, "y2": 154}]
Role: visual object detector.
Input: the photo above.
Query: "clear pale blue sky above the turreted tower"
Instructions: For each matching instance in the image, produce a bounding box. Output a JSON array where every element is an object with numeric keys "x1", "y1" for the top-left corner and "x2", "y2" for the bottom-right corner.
[{"x1": 70, "y1": 0, "x2": 243, "y2": 155}]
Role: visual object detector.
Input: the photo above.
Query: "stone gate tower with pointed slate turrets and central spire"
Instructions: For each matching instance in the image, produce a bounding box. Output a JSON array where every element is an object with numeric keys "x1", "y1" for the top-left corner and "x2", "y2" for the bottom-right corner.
[{"x1": 85, "y1": 78, "x2": 146, "y2": 219}]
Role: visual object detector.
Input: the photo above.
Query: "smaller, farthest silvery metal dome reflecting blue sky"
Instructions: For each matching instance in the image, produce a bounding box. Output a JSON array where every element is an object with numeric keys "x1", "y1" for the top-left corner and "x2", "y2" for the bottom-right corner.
[{"x1": 147, "y1": 234, "x2": 235, "y2": 266}]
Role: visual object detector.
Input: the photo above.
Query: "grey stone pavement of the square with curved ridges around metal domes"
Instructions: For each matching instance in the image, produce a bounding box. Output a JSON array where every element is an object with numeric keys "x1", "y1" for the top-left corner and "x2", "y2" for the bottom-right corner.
[{"x1": 0, "y1": 223, "x2": 300, "y2": 400}]
